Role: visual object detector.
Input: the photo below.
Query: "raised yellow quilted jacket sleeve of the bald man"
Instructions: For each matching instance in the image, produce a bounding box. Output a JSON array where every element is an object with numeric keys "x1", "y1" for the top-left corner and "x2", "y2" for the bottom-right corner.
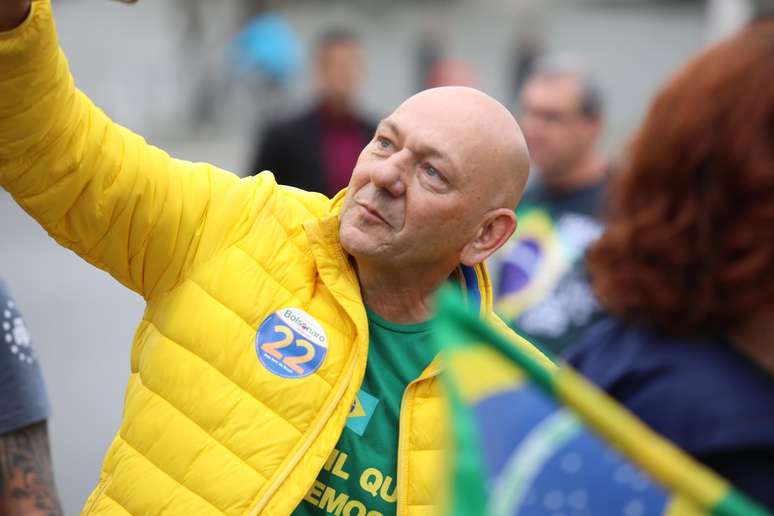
[{"x1": 0, "y1": 0, "x2": 276, "y2": 299}]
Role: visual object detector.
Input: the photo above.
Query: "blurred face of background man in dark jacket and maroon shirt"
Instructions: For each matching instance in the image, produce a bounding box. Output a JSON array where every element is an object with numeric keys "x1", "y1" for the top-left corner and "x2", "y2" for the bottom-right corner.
[{"x1": 315, "y1": 41, "x2": 363, "y2": 105}]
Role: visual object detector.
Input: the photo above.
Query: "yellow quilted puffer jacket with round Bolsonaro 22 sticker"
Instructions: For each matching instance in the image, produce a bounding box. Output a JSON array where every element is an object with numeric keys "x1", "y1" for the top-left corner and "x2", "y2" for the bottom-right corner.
[{"x1": 0, "y1": 0, "x2": 556, "y2": 516}]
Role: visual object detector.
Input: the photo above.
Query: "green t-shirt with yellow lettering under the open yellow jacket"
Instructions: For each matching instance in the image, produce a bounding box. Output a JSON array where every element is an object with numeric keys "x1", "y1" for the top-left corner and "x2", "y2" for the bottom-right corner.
[{"x1": 293, "y1": 310, "x2": 435, "y2": 516}]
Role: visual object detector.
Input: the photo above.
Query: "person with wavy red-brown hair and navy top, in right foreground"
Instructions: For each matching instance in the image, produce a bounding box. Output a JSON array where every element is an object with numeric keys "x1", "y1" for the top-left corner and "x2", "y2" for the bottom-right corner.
[{"x1": 568, "y1": 21, "x2": 774, "y2": 509}]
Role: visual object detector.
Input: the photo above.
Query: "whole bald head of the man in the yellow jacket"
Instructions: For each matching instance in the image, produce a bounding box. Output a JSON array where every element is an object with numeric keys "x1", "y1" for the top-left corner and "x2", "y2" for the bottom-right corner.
[{"x1": 339, "y1": 87, "x2": 529, "y2": 270}]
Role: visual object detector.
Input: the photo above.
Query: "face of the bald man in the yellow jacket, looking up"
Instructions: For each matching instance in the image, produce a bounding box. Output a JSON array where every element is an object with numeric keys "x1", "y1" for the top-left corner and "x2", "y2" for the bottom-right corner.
[{"x1": 340, "y1": 96, "x2": 486, "y2": 267}]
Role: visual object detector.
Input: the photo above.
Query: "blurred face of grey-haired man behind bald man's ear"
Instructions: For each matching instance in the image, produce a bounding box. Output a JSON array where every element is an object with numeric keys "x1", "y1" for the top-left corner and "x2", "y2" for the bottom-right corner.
[{"x1": 520, "y1": 76, "x2": 599, "y2": 181}]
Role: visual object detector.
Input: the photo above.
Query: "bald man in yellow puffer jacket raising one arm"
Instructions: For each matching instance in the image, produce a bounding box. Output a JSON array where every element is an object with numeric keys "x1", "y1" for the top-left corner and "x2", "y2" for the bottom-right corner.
[{"x1": 0, "y1": 0, "x2": 545, "y2": 516}]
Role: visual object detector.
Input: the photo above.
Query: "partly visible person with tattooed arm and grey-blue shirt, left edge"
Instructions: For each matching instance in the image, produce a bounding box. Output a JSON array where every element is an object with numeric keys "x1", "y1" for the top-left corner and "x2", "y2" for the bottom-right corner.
[{"x1": 0, "y1": 280, "x2": 62, "y2": 516}]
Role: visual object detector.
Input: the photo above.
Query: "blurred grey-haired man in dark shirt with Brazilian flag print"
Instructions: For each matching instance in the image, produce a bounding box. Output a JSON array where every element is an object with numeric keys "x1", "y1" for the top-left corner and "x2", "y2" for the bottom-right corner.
[{"x1": 489, "y1": 56, "x2": 610, "y2": 354}]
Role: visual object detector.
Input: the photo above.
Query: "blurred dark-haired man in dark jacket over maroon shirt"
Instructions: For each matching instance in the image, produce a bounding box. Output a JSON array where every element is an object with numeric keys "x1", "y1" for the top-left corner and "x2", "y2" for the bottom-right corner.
[{"x1": 249, "y1": 28, "x2": 375, "y2": 197}]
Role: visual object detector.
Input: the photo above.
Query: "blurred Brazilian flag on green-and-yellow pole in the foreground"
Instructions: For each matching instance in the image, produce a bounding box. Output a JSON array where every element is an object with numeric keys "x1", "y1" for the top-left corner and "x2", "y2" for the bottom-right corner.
[{"x1": 433, "y1": 289, "x2": 769, "y2": 516}]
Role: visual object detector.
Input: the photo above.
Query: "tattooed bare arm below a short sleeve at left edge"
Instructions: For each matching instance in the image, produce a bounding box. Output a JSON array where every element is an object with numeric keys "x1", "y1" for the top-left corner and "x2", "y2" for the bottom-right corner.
[{"x1": 0, "y1": 421, "x2": 62, "y2": 516}]
